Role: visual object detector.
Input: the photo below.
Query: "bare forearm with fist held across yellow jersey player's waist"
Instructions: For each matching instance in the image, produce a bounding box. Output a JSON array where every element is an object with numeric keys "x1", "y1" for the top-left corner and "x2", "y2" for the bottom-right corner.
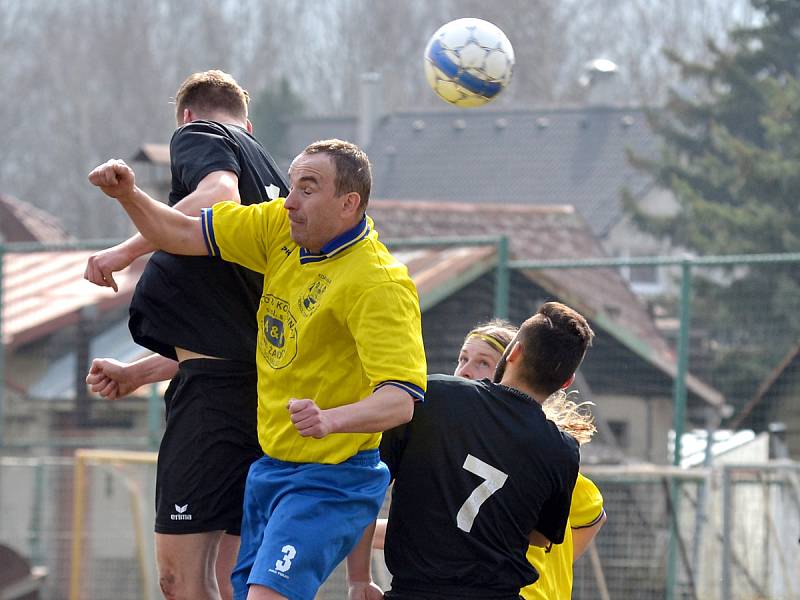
[{"x1": 287, "y1": 385, "x2": 414, "y2": 438}]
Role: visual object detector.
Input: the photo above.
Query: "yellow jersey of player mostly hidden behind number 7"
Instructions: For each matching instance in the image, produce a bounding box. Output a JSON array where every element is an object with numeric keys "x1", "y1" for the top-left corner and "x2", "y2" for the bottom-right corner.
[{"x1": 520, "y1": 473, "x2": 603, "y2": 600}]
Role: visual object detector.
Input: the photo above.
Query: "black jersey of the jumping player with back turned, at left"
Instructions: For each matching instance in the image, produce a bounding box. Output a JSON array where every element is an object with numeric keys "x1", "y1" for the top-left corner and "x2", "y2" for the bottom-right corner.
[{"x1": 129, "y1": 121, "x2": 288, "y2": 362}]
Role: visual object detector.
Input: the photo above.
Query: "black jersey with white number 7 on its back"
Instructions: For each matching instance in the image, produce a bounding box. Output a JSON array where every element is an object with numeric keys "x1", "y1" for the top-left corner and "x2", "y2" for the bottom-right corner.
[{"x1": 381, "y1": 375, "x2": 580, "y2": 598}]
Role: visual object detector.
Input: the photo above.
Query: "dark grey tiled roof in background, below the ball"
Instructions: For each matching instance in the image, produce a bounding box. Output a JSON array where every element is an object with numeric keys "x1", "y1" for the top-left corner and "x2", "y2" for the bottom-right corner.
[{"x1": 288, "y1": 107, "x2": 659, "y2": 236}]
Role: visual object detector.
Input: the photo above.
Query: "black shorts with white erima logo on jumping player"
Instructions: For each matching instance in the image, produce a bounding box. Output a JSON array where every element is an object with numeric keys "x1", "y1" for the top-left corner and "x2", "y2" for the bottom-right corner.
[{"x1": 155, "y1": 358, "x2": 263, "y2": 535}]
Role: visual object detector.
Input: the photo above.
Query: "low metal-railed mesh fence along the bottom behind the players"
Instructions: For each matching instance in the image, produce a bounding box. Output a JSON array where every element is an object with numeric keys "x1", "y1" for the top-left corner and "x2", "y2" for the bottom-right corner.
[{"x1": 0, "y1": 458, "x2": 800, "y2": 600}]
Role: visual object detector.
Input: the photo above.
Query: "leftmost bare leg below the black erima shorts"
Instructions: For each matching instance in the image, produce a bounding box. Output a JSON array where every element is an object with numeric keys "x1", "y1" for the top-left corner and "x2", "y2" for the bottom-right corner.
[{"x1": 156, "y1": 531, "x2": 223, "y2": 600}]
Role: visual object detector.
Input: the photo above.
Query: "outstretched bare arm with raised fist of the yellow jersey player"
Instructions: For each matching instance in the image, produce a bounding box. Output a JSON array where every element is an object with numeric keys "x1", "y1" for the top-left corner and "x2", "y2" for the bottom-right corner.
[{"x1": 89, "y1": 159, "x2": 206, "y2": 256}]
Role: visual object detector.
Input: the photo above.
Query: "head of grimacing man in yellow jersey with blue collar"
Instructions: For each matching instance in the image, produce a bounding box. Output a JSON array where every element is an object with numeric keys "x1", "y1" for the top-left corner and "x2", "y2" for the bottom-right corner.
[{"x1": 284, "y1": 140, "x2": 372, "y2": 252}]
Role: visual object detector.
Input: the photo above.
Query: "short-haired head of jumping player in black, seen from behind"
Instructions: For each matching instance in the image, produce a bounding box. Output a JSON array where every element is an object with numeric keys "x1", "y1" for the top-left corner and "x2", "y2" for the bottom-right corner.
[{"x1": 175, "y1": 70, "x2": 250, "y2": 127}]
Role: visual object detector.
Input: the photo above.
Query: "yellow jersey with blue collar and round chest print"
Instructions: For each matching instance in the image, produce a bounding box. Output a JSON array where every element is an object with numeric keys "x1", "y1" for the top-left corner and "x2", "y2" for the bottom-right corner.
[{"x1": 201, "y1": 199, "x2": 427, "y2": 464}]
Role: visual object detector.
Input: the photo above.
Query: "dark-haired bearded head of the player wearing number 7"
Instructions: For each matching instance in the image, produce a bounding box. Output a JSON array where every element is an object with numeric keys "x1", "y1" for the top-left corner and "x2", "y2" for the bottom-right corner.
[{"x1": 494, "y1": 302, "x2": 594, "y2": 402}]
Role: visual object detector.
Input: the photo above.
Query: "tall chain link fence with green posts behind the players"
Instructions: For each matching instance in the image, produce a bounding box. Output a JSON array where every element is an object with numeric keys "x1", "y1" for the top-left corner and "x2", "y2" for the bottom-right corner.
[{"x1": 0, "y1": 245, "x2": 800, "y2": 600}]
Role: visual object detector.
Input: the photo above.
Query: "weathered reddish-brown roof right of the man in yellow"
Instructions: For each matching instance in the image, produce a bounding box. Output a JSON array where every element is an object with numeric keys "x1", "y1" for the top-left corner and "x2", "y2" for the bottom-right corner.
[{"x1": 368, "y1": 200, "x2": 723, "y2": 406}]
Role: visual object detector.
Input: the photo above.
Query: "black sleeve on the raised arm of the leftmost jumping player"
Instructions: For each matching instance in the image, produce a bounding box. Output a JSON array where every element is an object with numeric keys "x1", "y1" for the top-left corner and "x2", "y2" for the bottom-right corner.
[{"x1": 169, "y1": 121, "x2": 241, "y2": 197}]
